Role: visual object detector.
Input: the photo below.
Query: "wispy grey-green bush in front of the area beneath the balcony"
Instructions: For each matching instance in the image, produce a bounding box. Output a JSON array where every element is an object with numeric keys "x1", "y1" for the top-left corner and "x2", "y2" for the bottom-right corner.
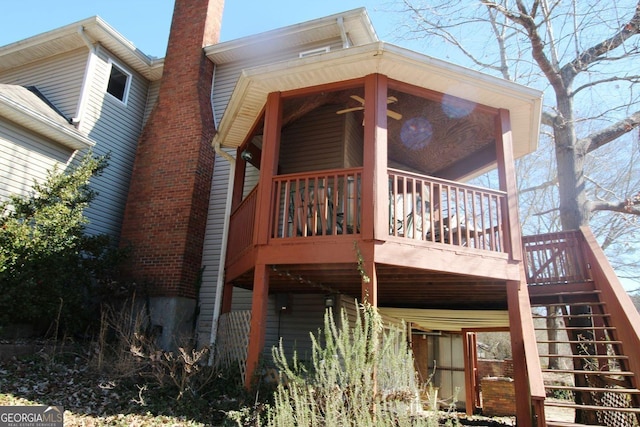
[{"x1": 268, "y1": 305, "x2": 438, "y2": 427}]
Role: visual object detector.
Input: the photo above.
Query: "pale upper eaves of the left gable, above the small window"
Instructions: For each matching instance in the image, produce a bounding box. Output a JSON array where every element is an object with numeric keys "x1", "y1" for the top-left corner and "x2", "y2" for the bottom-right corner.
[{"x1": 0, "y1": 16, "x2": 164, "y2": 81}]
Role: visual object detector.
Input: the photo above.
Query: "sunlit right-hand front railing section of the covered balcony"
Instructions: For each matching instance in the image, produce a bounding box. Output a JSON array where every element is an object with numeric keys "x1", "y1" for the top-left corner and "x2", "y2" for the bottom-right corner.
[{"x1": 389, "y1": 169, "x2": 506, "y2": 252}]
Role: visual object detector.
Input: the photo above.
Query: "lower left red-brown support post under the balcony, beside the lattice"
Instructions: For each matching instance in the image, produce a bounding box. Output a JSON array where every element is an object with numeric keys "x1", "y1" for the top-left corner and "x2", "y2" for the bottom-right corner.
[{"x1": 244, "y1": 264, "x2": 269, "y2": 389}]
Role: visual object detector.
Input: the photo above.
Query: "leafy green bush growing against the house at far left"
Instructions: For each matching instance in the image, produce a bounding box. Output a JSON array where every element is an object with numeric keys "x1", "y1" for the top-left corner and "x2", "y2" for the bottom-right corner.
[{"x1": 0, "y1": 154, "x2": 120, "y2": 333}]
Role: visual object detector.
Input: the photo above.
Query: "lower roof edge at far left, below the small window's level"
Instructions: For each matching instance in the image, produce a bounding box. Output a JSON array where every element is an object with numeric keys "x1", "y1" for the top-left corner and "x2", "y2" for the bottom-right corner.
[{"x1": 0, "y1": 84, "x2": 94, "y2": 150}]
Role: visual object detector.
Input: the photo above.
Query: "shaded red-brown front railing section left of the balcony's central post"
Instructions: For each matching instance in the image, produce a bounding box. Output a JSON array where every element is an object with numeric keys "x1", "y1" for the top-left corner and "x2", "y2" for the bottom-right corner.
[{"x1": 271, "y1": 168, "x2": 362, "y2": 238}]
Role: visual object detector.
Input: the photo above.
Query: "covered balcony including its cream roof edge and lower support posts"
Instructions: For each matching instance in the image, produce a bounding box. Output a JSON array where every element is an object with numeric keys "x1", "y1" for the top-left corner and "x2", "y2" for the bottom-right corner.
[{"x1": 215, "y1": 43, "x2": 544, "y2": 425}]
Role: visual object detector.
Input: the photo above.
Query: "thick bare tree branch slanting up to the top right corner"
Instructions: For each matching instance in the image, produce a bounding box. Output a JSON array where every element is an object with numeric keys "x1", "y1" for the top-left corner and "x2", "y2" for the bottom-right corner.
[{"x1": 561, "y1": 0, "x2": 640, "y2": 82}]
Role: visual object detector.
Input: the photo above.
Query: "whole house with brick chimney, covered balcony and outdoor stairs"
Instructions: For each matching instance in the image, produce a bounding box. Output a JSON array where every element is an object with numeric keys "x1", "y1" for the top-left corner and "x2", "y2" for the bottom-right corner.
[{"x1": 0, "y1": 0, "x2": 640, "y2": 426}]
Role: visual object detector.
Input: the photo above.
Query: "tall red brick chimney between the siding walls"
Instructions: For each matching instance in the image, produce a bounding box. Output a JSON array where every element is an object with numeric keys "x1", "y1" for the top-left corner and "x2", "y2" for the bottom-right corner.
[{"x1": 121, "y1": 0, "x2": 224, "y2": 347}]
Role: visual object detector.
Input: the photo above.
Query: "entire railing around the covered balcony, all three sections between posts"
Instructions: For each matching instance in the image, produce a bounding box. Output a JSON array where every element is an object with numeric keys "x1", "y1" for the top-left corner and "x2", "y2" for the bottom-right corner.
[{"x1": 228, "y1": 168, "x2": 508, "y2": 258}]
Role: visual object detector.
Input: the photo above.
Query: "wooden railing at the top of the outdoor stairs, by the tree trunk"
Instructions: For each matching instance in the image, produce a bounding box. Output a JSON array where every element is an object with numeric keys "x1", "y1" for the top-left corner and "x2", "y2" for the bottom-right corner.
[{"x1": 522, "y1": 231, "x2": 589, "y2": 285}]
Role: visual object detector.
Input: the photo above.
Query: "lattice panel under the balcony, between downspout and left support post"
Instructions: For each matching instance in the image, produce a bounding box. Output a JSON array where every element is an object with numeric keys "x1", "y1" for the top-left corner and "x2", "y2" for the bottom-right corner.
[{"x1": 215, "y1": 310, "x2": 251, "y2": 384}]
